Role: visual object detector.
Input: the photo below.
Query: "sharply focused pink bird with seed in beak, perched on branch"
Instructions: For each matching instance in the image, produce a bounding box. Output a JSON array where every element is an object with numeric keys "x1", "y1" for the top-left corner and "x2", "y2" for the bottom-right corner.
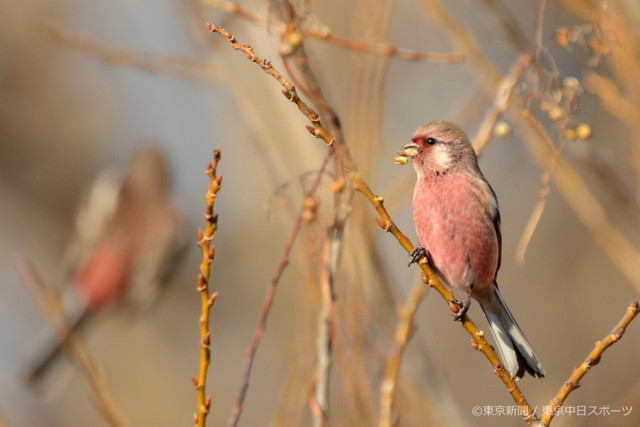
[{"x1": 404, "y1": 120, "x2": 545, "y2": 378}]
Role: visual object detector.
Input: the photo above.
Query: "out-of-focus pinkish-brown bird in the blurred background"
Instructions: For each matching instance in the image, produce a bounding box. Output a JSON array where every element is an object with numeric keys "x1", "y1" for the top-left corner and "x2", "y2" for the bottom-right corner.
[{"x1": 26, "y1": 146, "x2": 186, "y2": 385}]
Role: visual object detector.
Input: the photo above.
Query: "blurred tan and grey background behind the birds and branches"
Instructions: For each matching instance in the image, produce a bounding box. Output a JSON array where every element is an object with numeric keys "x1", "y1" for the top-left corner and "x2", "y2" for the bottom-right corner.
[{"x1": 0, "y1": 0, "x2": 640, "y2": 426}]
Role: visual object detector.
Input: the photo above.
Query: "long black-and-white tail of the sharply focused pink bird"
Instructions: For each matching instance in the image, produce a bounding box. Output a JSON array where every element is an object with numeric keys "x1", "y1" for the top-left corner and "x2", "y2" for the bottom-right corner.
[{"x1": 480, "y1": 286, "x2": 545, "y2": 378}]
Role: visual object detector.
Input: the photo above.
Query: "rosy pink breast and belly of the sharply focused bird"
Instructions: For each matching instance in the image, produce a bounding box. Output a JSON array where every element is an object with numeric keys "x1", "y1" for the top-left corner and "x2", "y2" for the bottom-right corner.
[{"x1": 413, "y1": 173, "x2": 499, "y2": 294}]
